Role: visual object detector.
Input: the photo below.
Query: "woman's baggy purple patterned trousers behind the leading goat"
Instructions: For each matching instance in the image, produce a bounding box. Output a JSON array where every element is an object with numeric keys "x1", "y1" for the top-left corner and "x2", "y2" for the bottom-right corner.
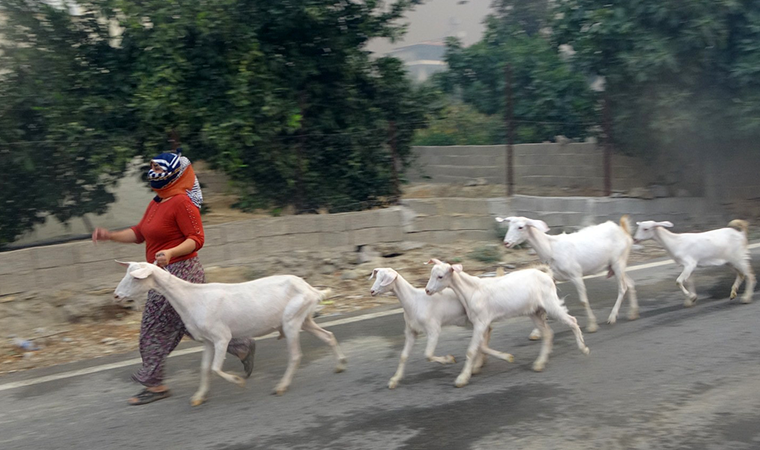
[{"x1": 132, "y1": 257, "x2": 251, "y2": 387}]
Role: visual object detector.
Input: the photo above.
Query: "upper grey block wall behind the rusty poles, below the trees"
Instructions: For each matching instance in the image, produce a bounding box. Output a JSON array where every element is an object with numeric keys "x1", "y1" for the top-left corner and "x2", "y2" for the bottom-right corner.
[{"x1": 407, "y1": 143, "x2": 653, "y2": 190}]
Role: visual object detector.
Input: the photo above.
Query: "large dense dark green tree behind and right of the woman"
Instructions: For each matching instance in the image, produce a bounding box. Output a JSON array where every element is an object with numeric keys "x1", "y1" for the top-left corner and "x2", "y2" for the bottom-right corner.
[{"x1": 104, "y1": 0, "x2": 434, "y2": 211}]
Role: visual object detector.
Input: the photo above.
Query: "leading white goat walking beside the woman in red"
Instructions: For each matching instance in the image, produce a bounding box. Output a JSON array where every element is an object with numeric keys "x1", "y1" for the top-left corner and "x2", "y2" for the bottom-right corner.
[{"x1": 115, "y1": 262, "x2": 346, "y2": 406}]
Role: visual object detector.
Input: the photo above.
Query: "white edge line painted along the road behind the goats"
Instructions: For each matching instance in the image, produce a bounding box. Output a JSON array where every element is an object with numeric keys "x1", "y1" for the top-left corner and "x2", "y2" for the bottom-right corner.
[{"x1": 0, "y1": 242, "x2": 760, "y2": 392}]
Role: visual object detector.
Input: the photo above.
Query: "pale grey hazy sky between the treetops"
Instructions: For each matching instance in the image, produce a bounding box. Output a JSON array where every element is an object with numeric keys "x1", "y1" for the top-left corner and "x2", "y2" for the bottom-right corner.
[{"x1": 369, "y1": 0, "x2": 491, "y2": 54}]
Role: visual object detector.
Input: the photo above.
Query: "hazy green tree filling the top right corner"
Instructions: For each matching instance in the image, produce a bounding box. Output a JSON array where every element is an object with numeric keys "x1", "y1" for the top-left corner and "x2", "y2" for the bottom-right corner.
[{"x1": 552, "y1": 0, "x2": 760, "y2": 156}]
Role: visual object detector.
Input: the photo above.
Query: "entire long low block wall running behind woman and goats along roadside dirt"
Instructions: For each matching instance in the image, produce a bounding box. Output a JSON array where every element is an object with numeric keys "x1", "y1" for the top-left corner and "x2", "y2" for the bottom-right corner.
[{"x1": 0, "y1": 196, "x2": 727, "y2": 298}]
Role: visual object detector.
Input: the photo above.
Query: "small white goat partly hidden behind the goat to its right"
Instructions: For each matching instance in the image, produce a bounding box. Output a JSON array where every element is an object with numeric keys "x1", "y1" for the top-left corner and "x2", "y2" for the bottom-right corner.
[{"x1": 369, "y1": 268, "x2": 491, "y2": 389}]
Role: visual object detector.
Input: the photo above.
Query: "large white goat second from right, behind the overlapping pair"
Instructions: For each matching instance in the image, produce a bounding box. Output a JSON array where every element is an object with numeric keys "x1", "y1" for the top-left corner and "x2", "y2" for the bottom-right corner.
[{"x1": 496, "y1": 216, "x2": 639, "y2": 339}]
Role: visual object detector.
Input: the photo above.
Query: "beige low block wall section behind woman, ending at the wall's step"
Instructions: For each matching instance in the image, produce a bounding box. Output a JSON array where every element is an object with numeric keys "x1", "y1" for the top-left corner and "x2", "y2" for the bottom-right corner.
[{"x1": 0, "y1": 207, "x2": 404, "y2": 296}]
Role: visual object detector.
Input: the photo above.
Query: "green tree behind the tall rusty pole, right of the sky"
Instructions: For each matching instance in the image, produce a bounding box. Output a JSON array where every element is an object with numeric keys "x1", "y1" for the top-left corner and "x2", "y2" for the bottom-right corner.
[{"x1": 435, "y1": 6, "x2": 596, "y2": 143}]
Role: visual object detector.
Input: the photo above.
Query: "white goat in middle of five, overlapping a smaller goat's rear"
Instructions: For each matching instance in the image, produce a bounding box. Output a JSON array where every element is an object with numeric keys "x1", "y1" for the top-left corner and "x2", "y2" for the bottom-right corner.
[{"x1": 425, "y1": 259, "x2": 589, "y2": 387}]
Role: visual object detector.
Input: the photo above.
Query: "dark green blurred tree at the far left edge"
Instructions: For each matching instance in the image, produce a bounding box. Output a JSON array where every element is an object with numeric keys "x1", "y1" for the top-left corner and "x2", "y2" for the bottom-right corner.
[{"x1": 0, "y1": 0, "x2": 136, "y2": 246}]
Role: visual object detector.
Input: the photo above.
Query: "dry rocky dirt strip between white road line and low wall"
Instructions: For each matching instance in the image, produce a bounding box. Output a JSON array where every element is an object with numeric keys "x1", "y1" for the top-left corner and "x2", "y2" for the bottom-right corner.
[{"x1": 0, "y1": 236, "x2": 664, "y2": 375}]
